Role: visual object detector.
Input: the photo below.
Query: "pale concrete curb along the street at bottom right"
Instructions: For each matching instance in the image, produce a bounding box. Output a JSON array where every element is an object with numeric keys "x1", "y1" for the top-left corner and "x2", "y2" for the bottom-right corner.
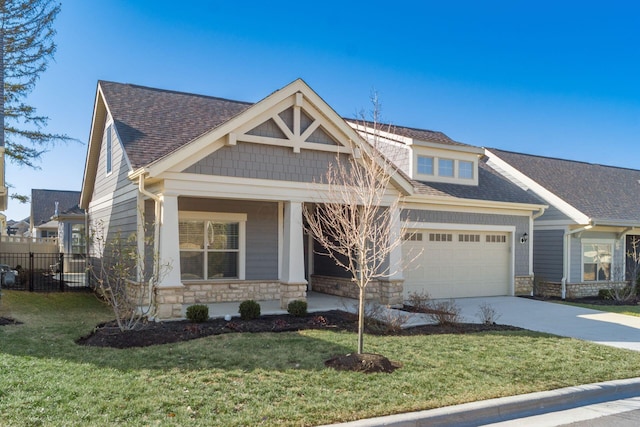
[{"x1": 321, "y1": 378, "x2": 640, "y2": 427}]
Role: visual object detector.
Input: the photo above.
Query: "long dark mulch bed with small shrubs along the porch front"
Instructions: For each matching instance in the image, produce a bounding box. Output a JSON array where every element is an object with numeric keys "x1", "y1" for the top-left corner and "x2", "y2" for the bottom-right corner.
[{"x1": 76, "y1": 310, "x2": 521, "y2": 348}]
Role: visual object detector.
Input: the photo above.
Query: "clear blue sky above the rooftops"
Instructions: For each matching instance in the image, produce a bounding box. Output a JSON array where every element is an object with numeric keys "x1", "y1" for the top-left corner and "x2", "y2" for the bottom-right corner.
[{"x1": 6, "y1": 0, "x2": 640, "y2": 219}]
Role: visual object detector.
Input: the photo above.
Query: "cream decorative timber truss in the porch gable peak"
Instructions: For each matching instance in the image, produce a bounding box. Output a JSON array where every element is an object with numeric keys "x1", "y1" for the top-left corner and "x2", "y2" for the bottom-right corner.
[{"x1": 226, "y1": 92, "x2": 344, "y2": 153}]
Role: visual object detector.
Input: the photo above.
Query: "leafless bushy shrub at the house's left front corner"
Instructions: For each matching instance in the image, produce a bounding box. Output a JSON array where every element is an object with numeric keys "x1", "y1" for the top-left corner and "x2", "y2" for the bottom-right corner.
[{"x1": 89, "y1": 222, "x2": 171, "y2": 331}]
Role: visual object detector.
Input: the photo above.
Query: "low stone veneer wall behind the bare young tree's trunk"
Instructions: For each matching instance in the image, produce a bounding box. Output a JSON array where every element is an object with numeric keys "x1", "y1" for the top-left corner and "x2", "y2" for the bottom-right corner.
[{"x1": 311, "y1": 275, "x2": 404, "y2": 306}]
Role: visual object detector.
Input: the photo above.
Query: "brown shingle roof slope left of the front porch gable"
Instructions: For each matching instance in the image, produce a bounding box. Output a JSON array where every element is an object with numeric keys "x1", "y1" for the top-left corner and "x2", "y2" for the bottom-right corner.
[{"x1": 99, "y1": 81, "x2": 252, "y2": 169}]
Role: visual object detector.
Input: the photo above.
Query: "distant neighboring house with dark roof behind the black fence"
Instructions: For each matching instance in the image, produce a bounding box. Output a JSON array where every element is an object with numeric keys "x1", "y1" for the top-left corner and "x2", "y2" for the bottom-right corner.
[{"x1": 30, "y1": 189, "x2": 86, "y2": 253}]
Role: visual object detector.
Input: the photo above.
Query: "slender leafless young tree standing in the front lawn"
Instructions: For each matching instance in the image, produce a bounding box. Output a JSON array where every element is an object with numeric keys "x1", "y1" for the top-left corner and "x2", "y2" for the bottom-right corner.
[{"x1": 303, "y1": 95, "x2": 403, "y2": 353}]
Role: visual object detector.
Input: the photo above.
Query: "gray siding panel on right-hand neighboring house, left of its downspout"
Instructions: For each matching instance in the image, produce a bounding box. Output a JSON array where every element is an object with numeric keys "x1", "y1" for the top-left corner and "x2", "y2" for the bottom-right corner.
[{"x1": 533, "y1": 230, "x2": 564, "y2": 282}]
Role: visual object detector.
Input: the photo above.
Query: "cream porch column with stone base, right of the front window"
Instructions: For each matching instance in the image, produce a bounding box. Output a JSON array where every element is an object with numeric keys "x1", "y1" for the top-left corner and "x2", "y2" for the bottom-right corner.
[{"x1": 280, "y1": 202, "x2": 307, "y2": 308}]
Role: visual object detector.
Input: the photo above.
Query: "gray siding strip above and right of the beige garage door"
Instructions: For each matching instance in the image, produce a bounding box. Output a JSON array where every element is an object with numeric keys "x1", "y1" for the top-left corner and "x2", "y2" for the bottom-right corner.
[{"x1": 401, "y1": 209, "x2": 529, "y2": 276}]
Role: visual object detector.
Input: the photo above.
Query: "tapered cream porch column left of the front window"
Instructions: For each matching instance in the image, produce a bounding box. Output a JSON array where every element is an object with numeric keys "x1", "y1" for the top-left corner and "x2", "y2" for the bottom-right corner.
[{"x1": 158, "y1": 194, "x2": 182, "y2": 287}]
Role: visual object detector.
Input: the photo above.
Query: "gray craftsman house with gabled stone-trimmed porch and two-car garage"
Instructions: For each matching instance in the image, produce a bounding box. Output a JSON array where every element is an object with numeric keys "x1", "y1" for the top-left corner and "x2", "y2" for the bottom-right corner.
[{"x1": 80, "y1": 80, "x2": 544, "y2": 318}]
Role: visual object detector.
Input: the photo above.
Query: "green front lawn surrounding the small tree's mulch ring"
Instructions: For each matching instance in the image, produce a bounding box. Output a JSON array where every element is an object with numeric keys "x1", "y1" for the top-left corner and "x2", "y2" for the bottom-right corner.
[{"x1": 0, "y1": 291, "x2": 640, "y2": 426}]
